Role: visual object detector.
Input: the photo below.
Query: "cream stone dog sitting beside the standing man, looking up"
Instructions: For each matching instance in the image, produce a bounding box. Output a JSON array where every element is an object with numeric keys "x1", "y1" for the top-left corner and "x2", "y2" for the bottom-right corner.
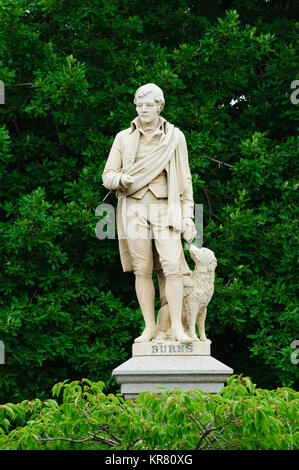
[{"x1": 154, "y1": 245, "x2": 217, "y2": 342}]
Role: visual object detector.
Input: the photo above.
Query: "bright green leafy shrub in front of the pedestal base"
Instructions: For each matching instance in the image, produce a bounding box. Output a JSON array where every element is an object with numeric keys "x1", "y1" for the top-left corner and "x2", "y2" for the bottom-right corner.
[{"x1": 0, "y1": 376, "x2": 299, "y2": 450}]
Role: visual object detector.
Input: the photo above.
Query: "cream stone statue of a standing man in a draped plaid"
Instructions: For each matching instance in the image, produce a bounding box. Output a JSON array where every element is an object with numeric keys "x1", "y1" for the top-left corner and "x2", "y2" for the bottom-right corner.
[{"x1": 102, "y1": 83, "x2": 196, "y2": 343}]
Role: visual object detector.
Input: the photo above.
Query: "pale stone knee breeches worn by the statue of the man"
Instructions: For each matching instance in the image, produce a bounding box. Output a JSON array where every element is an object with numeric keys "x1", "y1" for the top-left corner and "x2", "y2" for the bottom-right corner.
[{"x1": 126, "y1": 191, "x2": 182, "y2": 276}]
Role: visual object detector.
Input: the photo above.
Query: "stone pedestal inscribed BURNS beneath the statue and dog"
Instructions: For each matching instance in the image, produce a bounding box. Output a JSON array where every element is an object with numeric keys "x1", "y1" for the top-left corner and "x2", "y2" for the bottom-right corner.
[{"x1": 112, "y1": 341, "x2": 233, "y2": 399}]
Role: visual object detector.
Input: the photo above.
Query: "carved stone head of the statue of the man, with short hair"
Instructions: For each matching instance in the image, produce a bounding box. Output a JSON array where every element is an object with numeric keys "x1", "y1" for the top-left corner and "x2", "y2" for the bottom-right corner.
[{"x1": 134, "y1": 83, "x2": 165, "y2": 123}]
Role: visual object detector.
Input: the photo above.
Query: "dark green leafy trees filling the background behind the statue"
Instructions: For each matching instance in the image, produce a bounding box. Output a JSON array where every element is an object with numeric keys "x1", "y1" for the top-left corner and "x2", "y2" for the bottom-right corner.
[{"x1": 0, "y1": 0, "x2": 299, "y2": 402}]
